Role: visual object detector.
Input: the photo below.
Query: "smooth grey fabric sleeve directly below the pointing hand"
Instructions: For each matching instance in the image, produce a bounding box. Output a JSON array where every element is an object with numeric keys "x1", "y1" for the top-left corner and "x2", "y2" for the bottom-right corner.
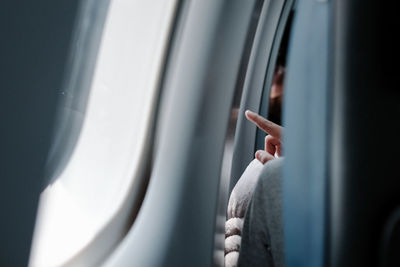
[{"x1": 238, "y1": 158, "x2": 284, "y2": 267}]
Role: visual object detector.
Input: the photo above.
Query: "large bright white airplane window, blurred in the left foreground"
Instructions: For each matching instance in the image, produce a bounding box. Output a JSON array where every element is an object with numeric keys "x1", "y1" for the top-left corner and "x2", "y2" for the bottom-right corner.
[{"x1": 30, "y1": 0, "x2": 178, "y2": 266}]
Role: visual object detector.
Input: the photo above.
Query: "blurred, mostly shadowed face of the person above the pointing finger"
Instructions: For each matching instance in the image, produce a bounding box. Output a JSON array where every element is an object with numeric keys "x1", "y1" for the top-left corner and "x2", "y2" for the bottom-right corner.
[{"x1": 268, "y1": 66, "x2": 285, "y2": 125}]
